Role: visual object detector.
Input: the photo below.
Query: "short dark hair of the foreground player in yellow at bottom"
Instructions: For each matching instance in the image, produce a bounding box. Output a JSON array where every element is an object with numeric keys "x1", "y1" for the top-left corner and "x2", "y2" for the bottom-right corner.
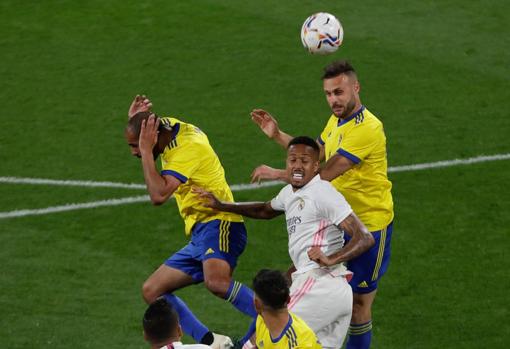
[{"x1": 253, "y1": 269, "x2": 290, "y2": 310}]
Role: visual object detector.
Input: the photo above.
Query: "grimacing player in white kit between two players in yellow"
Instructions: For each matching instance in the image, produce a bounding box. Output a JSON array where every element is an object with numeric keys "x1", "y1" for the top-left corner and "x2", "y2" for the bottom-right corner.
[{"x1": 195, "y1": 137, "x2": 374, "y2": 348}]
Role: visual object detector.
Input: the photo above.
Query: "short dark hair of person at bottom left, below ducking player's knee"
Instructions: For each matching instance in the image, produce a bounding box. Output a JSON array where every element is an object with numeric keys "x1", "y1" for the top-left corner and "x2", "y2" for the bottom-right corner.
[{"x1": 143, "y1": 297, "x2": 179, "y2": 343}]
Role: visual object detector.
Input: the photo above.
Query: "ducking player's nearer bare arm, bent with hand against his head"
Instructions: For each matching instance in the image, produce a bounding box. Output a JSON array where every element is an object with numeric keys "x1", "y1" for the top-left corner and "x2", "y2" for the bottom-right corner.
[{"x1": 138, "y1": 114, "x2": 181, "y2": 205}]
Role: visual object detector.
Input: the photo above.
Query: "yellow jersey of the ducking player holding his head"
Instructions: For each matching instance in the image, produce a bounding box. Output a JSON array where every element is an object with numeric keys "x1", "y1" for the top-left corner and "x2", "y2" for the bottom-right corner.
[{"x1": 160, "y1": 117, "x2": 243, "y2": 235}]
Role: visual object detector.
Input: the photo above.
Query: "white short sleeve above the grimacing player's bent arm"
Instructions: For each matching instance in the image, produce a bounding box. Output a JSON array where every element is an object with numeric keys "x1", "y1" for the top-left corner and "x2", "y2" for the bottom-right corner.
[{"x1": 317, "y1": 182, "x2": 352, "y2": 225}]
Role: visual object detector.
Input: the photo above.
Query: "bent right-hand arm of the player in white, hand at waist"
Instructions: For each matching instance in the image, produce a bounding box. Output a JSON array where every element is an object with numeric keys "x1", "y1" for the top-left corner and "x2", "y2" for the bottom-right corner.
[{"x1": 308, "y1": 213, "x2": 375, "y2": 265}]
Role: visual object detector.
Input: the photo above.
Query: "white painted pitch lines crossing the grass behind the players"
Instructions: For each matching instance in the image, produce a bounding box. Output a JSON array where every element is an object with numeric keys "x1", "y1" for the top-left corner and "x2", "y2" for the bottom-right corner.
[{"x1": 0, "y1": 153, "x2": 510, "y2": 219}]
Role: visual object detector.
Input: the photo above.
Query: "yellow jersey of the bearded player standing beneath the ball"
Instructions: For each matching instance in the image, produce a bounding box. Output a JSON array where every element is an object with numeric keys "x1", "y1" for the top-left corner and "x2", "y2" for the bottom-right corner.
[{"x1": 318, "y1": 106, "x2": 393, "y2": 231}]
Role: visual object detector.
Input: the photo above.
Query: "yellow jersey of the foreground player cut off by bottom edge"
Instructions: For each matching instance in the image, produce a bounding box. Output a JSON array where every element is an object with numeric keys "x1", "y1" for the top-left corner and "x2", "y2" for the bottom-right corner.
[{"x1": 255, "y1": 313, "x2": 322, "y2": 349}]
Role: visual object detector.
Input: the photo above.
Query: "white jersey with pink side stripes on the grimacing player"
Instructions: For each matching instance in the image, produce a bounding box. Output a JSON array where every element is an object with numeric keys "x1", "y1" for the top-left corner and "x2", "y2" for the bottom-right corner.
[{"x1": 271, "y1": 175, "x2": 352, "y2": 274}]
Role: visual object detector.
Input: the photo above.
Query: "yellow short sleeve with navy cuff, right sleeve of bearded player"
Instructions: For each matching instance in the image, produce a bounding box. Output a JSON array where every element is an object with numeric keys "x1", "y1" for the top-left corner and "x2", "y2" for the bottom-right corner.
[{"x1": 337, "y1": 124, "x2": 384, "y2": 164}]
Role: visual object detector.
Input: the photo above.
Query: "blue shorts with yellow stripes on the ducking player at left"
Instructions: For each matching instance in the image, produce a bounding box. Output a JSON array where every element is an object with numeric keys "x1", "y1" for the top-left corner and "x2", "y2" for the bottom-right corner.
[{"x1": 165, "y1": 219, "x2": 247, "y2": 282}]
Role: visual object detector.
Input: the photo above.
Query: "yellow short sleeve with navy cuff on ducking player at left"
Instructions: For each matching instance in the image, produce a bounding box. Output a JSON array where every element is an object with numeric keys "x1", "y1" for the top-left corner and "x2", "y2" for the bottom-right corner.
[{"x1": 161, "y1": 143, "x2": 201, "y2": 183}]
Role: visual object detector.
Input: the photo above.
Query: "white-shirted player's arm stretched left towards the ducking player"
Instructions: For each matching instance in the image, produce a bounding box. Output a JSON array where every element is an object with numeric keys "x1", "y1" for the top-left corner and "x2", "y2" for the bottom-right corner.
[{"x1": 193, "y1": 187, "x2": 283, "y2": 219}]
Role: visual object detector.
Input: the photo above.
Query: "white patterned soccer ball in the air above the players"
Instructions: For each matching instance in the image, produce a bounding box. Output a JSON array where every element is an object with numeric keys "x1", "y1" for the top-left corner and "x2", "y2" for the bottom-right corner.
[{"x1": 301, "y1": 12, "x2": 344, "y2": 55}]
